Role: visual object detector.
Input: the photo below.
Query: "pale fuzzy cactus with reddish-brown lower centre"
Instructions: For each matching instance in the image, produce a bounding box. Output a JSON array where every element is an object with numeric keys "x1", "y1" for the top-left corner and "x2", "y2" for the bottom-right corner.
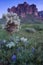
[{"x1": 4, "y1": 12, "x2": 20, "y2": 32}]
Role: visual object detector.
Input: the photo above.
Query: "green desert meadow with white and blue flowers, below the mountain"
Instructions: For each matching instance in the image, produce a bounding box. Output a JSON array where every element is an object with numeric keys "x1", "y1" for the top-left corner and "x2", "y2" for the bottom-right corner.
[{"x1": 0, "y1": 17, "x2": 43, "y2": 65}]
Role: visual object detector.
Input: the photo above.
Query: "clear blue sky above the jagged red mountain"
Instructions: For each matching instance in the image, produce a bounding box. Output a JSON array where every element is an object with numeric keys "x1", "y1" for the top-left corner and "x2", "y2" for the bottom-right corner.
[{"x1": 0, "y1": 0, "x2": 43, "y2": 18}]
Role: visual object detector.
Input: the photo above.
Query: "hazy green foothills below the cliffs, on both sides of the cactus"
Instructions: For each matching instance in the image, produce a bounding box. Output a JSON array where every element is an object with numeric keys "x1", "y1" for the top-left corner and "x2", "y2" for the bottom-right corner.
[{"x1": 0, "y1": 15, "x2": 43, "y2": 24}]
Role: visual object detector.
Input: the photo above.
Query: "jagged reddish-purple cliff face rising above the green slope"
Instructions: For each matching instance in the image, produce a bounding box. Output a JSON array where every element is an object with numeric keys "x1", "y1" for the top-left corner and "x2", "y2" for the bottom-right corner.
[{"x1": 8, "y1": 2, "x2": 38, "y2": 17}]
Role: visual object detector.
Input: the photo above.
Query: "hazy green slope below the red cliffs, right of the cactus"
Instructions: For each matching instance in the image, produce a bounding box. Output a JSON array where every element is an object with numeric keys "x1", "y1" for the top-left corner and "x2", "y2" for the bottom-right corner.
[{"x1": 21, "y1": 15, "x2": 43, "y2": 24}]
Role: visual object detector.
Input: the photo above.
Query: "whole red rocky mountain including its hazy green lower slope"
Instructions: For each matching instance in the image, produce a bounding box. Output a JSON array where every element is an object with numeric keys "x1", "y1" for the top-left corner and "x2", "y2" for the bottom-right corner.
[{"x1": 7, "y1": 2, "x2": 43, "y2": 23}]
